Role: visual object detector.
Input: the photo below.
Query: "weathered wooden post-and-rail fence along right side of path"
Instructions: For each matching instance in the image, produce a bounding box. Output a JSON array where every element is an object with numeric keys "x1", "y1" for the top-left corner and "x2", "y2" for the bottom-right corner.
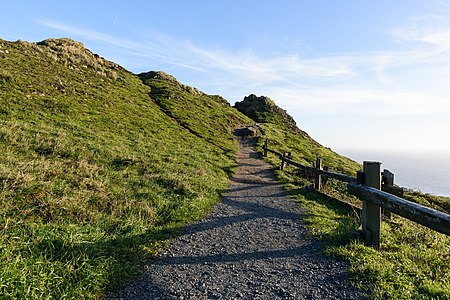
[{"x1": 263, "y1": 139, "x2": 450, "y2": 249}]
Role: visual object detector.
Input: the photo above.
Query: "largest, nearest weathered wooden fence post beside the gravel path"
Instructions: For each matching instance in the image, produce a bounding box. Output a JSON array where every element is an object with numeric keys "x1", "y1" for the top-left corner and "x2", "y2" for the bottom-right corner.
[{"x1": 361, "y1": 161, "x2": 381, "y2": 249}]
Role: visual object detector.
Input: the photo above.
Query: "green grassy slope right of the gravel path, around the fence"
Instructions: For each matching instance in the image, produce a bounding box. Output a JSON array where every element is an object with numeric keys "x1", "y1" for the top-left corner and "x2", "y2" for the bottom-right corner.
[{"x1": 236, "y1": 97, "x2": 450, "y2": 299}]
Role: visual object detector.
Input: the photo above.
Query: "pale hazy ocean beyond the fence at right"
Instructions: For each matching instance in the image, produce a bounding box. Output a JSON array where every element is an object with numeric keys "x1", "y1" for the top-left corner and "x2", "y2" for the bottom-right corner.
[{"x1": 336, "y1": 149, "x2": 450, "y2": 197}]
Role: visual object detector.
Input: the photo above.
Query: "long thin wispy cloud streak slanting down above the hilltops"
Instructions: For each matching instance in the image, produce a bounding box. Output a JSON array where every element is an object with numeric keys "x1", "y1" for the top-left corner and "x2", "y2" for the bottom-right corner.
[{"x1": 39, "y1": 20, "x2": 355, "y2": 83}]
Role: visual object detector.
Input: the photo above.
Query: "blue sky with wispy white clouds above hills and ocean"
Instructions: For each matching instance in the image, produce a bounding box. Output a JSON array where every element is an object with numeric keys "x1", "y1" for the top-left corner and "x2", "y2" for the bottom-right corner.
[{"x1": 0, "y1": 0, "x2": 450, "y2": 152}]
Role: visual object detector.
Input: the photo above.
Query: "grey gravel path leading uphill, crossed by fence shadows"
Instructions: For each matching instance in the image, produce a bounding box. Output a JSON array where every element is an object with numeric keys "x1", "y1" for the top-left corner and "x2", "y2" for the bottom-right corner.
[{"x1": 106, "y1": 138, "x2": 366, "y2": 299}]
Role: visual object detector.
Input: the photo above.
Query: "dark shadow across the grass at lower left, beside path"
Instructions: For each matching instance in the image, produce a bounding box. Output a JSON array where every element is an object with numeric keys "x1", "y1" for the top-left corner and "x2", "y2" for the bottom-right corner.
[{"x1": 29, "y1": 225, "x2": 182, "y2": 298}]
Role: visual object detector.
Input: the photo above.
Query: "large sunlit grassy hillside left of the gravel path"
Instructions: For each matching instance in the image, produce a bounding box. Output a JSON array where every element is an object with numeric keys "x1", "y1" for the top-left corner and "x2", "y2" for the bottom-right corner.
[{"x1": 0, "y1": 39, "x2": 247, "y2": 299}]
